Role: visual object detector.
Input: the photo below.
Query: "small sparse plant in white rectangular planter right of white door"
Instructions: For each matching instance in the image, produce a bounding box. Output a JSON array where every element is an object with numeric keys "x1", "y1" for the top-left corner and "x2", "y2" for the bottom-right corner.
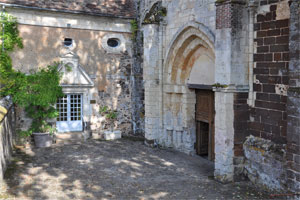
[{"x1": 99, "y1": 106, "x2": 121, "y2": 140}]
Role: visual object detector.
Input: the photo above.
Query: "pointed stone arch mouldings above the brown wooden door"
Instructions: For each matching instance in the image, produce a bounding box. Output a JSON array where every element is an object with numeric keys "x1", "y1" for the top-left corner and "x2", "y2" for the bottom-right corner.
[{"x1": 164, "y1": 22, "x2": 215, "y2": 85}]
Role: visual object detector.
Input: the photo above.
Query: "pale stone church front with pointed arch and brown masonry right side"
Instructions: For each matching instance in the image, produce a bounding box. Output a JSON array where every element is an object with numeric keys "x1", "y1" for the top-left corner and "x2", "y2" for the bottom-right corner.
[{"x1": 139, "y1": 0, "x2": 300, "y2": 191}]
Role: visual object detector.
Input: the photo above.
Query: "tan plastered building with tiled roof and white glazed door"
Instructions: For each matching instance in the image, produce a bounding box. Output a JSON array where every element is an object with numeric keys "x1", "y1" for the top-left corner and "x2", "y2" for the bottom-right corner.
[{"x1": 0, "y1": 0, "x2": 144, "y2": 137}]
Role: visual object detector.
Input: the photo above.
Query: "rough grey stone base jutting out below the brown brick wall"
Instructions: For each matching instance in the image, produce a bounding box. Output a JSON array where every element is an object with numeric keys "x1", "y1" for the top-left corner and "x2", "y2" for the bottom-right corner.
[{"x1": 244, "y1": 136, "x2": 286, "y2": 192}]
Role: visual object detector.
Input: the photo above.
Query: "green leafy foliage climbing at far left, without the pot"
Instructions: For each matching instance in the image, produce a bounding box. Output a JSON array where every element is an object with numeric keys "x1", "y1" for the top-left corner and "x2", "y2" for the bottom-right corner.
[{"x1": 0, "y1": 14, "x2": 63, "y2": 135}]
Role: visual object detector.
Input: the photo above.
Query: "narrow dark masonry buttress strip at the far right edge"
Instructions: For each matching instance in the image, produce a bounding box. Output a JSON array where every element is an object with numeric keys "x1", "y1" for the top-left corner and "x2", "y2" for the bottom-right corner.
[{"x1": 286, "y1": 0, "x2": 300, "y2": 192}]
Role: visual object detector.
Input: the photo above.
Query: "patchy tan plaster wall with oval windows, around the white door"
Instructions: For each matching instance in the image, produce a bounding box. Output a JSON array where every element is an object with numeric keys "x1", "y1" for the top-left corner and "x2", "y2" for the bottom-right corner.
[{"x1": 6, "y1": 8, "x2": 137, "y2": 134}]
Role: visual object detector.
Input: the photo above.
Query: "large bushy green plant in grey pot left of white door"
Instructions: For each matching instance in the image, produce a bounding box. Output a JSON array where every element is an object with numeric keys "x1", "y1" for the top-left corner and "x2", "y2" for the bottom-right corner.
[{"x1": 12, "y1": 64, "x2": 63, "y2": 147}]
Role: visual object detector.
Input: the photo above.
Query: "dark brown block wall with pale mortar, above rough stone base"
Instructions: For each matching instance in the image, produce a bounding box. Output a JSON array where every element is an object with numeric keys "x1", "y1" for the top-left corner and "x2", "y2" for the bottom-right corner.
[{"x1": 249, "y1": 0, "x2": 289, "y2": 144}]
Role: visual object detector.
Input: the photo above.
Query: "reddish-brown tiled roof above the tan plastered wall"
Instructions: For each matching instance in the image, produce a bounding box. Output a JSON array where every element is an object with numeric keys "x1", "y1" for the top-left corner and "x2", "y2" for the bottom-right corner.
[{"x1": 0, "y1": 0, "x2": 135, "y2": 18}]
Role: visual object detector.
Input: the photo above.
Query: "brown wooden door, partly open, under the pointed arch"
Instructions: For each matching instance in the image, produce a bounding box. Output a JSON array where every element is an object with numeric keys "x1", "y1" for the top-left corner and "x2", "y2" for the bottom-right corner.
[{"x1": 196, "y1": 90, "x2": 215, "y2": 160}]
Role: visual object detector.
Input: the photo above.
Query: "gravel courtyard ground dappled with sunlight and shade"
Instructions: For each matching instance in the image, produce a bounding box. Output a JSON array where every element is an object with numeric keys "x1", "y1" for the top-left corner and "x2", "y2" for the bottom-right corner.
[{"x1": 0, "y1": 139, "x2": 276, "y2": 200}]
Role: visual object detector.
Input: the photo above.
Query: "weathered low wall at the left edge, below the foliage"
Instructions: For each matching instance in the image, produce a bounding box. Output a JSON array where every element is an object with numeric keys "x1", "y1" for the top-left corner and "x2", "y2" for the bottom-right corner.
[{"x1": 0, "y1": 97, "x2": 15, "y2": 182}]
